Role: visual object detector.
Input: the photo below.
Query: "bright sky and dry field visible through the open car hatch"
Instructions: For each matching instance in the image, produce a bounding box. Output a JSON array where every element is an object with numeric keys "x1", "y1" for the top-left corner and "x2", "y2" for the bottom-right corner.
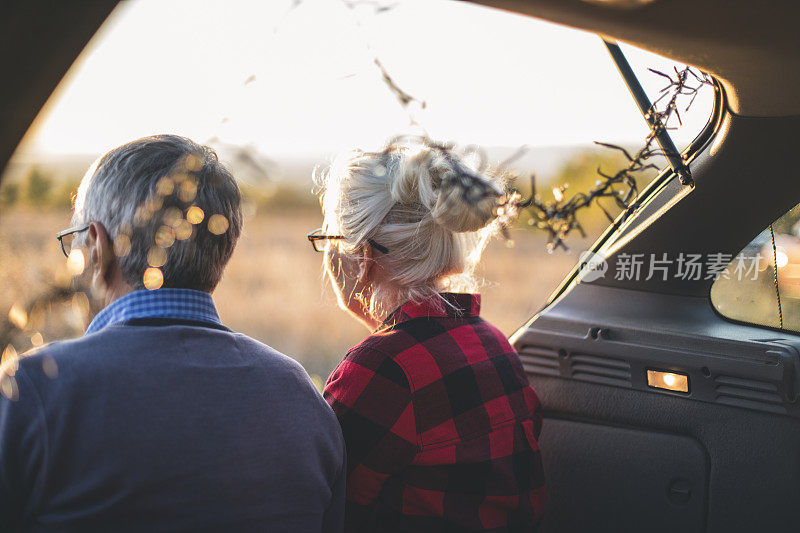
[{"x1": 0, "y1": 0, "x2": 713, "y2": 376}]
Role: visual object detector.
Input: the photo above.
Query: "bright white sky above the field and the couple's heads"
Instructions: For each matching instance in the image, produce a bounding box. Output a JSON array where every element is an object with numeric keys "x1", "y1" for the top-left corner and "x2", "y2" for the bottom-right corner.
[{"x1": 21, "y1": 0, "x2": 712, "y2": 156}]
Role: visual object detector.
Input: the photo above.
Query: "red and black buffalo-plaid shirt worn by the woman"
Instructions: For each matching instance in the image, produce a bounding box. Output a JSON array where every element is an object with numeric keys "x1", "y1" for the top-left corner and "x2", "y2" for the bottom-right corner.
[{"x1": 325, "y1": 293, "x2": 545, "y2": 532}]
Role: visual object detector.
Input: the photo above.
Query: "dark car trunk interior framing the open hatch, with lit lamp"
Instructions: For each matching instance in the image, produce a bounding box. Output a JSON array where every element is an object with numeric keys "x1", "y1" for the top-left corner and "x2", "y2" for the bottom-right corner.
[{"x1": 0, "y1": 0, "x2": 800, "y2": 532}]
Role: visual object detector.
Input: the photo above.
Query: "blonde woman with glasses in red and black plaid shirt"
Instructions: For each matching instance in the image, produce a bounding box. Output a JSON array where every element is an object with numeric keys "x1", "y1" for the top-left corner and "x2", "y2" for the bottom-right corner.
[{"x1": 309, "y1": 141, "x2": 544, "y2": 532}]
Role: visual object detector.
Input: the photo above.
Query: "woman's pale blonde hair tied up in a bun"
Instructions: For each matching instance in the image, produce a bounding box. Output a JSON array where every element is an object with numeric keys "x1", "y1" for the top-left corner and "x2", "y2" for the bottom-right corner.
[{"x1": 316, "y1": 141, "x2": 503, "y2": 317}]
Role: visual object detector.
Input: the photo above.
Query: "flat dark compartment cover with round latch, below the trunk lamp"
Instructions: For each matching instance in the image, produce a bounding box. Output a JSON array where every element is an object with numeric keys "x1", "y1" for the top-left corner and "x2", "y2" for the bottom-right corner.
[{"x1": 540, "y1": 417, "x2": 709, "y2": 532}]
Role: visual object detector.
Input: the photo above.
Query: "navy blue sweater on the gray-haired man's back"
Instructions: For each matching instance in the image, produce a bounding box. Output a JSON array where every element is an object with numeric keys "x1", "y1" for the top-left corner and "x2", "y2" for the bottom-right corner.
[{"x1": 0, "y1": 319, "x2": 345, "y2": 532}]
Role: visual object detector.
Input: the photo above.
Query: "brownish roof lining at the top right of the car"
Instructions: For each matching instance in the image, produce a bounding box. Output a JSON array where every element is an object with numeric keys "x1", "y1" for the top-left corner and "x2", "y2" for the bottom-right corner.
[{"x1": 470, "y1": 0, "x2": 800, "y2": 116}]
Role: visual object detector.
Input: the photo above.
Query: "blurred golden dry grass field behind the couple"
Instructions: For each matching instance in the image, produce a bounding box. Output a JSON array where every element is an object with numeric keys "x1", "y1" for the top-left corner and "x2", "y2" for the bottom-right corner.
[{"x1": 0, "y1": 208, "x2": 590, "y2": 379}]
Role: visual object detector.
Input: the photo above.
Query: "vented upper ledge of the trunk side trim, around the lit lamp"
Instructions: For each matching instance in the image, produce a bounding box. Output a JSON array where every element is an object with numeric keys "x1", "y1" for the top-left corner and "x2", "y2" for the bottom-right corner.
[{"x1": 513, "y1": 284, "x2": 800, "y2": 418}]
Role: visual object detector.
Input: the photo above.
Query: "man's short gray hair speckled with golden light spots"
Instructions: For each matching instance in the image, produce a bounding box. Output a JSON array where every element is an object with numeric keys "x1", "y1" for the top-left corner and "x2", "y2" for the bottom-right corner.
[{"x1": 72, "y1": 135, "x2": 242, "y2": 292}]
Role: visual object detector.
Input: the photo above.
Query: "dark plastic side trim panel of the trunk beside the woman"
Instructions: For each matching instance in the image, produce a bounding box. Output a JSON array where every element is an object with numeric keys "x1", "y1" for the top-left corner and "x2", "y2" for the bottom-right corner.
[{"x1": 512, "y1": 283, "x2": 800, "y2": 532}]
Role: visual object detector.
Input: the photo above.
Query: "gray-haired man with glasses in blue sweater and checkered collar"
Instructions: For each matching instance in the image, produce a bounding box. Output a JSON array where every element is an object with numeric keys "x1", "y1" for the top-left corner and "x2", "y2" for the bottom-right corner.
[{"x1": 0, "y1": 135, "x2": 346, "y2": 532}]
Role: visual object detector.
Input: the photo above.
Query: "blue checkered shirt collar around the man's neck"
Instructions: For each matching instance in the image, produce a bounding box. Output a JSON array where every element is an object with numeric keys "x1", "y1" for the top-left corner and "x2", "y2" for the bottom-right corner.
[{"x1": 86, "y1": 289, "x2": 222, "y2": 335}]
